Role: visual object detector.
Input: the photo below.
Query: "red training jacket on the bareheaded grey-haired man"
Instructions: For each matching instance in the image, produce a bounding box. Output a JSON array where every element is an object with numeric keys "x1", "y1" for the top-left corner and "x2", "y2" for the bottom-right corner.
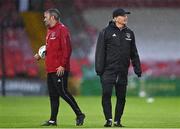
[{"x1": 45, "y1": 22, "x2": 71, "y2": 73}]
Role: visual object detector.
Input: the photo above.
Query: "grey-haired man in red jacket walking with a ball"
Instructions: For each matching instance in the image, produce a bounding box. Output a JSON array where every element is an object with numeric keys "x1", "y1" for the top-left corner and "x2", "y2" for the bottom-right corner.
[{"x1": 34, "y1": 9, "x2": 85, "y2": 126}]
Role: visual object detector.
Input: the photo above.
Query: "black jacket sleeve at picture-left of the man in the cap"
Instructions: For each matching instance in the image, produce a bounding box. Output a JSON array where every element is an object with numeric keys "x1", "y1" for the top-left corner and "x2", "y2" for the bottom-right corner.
[{"x1": 95, "y1": 30, "x2": 105, "y2": 76}]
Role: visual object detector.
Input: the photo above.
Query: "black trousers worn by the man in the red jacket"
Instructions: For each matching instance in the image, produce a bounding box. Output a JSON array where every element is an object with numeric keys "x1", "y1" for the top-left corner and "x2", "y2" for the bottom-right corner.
[{"x1": 47, "y1": 72, "x2": 82, "y2": 121}]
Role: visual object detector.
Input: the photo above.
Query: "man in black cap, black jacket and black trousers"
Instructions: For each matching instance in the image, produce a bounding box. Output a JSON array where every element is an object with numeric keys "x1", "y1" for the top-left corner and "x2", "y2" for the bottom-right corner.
[{"x1": 95, "y1": 8, "x2": 141, "y2": 127}]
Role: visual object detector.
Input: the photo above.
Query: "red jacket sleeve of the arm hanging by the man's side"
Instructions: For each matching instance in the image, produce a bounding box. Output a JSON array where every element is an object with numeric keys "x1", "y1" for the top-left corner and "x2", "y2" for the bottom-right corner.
[{"x1": 61, "y1": 27, "x2": 72, "y2": 68}]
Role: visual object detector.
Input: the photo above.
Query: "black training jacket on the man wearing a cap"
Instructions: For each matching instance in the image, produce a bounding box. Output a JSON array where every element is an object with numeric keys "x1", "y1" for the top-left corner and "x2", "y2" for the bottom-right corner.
[{"x1": 95, "y1": 21, "x2": 141, "y2": 83}]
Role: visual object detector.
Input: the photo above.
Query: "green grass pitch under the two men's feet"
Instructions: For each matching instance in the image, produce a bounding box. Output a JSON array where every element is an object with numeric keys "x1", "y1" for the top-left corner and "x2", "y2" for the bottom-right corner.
[{"x1": 0, "y1": 96, "x2": 180, "y2": 128}]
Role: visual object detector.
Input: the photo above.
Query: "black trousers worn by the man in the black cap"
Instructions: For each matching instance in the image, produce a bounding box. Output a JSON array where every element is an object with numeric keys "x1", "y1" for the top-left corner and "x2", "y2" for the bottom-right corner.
[{"x1": 101, "y1": 82, "x2": 127, "y2": 122}]
